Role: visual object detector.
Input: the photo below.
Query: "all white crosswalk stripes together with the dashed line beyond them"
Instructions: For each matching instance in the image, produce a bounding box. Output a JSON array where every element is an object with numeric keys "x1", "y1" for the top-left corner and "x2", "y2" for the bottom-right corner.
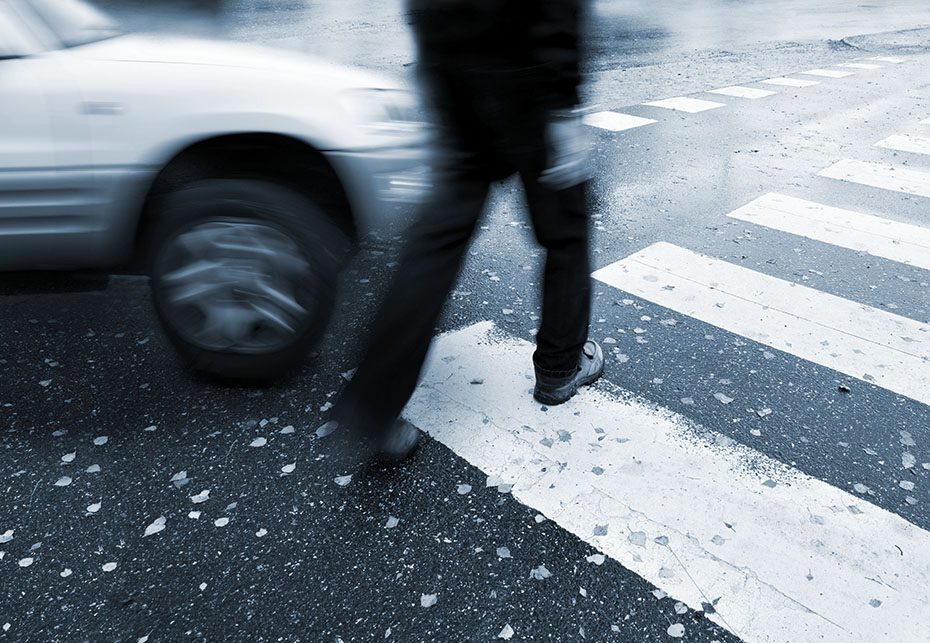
[{"x1": 406, "y1": 57, "x2": 930, "y2": 643}]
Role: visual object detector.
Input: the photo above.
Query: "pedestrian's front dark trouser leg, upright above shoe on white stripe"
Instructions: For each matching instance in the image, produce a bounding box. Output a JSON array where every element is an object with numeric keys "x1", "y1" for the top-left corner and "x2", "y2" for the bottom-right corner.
[{"x1": 521, "y1": 171, "x2": 591, "y2": 377}]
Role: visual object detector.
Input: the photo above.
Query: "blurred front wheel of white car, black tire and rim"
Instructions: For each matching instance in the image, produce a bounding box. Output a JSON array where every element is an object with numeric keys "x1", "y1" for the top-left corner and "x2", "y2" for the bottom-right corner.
[{"x1": 148, "y1": 179, "x2": 347, "y2": 382}]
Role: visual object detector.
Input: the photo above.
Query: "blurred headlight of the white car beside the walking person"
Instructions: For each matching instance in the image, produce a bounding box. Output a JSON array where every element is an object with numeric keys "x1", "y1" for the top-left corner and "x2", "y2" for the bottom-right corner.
[{"x1": 343, "y1": 89, "x2": 424, "y2": 135}]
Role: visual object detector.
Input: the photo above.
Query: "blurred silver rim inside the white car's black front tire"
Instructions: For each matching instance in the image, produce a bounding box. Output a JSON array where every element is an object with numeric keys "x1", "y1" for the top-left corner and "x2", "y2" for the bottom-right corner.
[{"x1": 157, "y1": 220, "x2": 312, "y2": 353}]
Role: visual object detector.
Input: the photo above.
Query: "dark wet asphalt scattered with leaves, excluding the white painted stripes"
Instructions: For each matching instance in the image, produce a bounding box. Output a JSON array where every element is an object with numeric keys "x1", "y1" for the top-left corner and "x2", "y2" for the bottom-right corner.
[{"x1": 0, "y1": 0, "x2": 930, "y2": 643}]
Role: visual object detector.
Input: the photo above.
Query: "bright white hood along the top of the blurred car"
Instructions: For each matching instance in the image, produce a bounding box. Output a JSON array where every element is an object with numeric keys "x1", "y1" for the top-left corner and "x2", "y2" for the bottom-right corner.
[{"x1": 82, "y1": 34, "x2": 401, "y2": 89}]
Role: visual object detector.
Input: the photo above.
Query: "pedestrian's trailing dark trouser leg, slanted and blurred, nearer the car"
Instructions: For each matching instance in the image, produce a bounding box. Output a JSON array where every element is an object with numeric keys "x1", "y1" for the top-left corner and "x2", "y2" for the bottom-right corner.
[{"x1": 334, "y1": 174, "x2": 490, "y2": 441}]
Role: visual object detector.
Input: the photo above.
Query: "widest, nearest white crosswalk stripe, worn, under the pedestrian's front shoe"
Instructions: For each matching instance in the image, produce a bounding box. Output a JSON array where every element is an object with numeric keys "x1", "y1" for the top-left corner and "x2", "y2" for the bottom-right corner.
[{"x1": 405, "y1": 322, "x2": 930, "y2": 643}]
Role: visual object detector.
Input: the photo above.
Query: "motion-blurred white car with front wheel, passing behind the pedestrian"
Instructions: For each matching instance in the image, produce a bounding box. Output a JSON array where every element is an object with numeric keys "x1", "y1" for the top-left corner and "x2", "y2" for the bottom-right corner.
[{"x1": 0, "y1": 0, "x2": 428, "y2": 379}]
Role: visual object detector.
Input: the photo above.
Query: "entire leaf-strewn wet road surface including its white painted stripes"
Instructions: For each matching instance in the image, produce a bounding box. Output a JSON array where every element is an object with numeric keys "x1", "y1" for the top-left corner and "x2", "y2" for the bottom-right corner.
[{"x1": 0, "y1": 0, "x2": 930, "y2": 643}]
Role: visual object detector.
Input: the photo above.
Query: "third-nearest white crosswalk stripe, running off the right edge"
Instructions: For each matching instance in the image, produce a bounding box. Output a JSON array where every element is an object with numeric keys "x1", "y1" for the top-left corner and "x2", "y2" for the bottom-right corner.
[{"x1": 727, "y1": 194, "x2": 930, "y2": 272}]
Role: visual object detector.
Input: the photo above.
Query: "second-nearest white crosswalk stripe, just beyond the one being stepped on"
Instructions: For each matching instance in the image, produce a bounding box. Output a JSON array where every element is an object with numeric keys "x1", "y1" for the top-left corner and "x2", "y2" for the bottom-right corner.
[{"x1": 594, "y1": 243, "x2": 930, "y2": 405}]
